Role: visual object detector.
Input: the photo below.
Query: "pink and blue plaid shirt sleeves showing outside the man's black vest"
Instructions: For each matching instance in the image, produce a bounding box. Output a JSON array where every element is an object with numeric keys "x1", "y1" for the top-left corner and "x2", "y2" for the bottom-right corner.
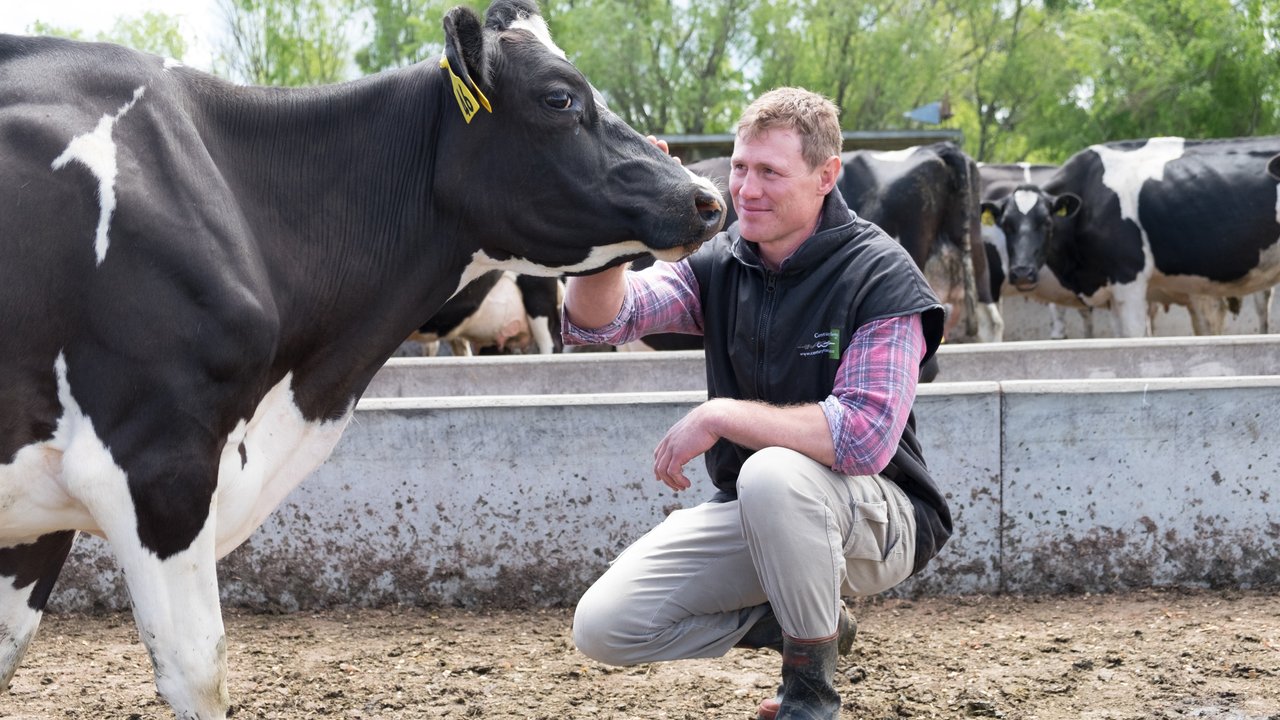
[{"x1": 563, "y1": 261, "x2": 925, "y2": 475}]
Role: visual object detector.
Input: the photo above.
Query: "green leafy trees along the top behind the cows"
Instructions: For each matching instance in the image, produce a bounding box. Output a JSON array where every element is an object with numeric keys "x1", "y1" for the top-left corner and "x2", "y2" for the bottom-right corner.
[{"x1": 47, "y1": 0, "x2": 1280, "y2": 161}]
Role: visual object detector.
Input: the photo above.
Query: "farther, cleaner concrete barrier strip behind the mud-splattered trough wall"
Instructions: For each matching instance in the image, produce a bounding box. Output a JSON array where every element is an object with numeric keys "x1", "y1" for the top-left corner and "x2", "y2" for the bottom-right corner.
[{"x1": 365, "y1": 334, "x2": 1280, "y2": 397}]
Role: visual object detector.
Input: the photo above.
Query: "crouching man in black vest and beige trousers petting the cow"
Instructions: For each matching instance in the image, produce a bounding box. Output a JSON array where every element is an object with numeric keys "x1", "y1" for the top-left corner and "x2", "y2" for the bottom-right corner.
[{"x1": 564, "y1": 88, "x2": 951, "y2": 720}]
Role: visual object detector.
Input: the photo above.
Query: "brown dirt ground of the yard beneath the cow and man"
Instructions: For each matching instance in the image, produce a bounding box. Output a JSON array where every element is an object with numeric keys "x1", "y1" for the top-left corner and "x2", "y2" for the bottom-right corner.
[{"x1": 0, "y1": 592, "x2": 1280, "y2": 720}]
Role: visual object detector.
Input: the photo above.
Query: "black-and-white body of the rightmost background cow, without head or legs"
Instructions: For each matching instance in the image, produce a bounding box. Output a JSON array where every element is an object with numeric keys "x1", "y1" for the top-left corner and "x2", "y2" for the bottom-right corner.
[{"x1": 1044, "y1": 137, "x2": 1280, "y2": 295}]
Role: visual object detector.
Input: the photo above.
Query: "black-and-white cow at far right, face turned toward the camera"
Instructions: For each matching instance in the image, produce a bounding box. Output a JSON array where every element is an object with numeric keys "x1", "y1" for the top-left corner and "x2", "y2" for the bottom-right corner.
[{"x1": 977, "y1": 137, "x2": 1280, "y2": 337}]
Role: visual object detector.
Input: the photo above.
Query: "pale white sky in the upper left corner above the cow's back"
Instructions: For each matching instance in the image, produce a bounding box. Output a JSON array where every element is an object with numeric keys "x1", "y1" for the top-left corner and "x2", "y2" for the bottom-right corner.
[{"x1": 0, "y1": 0, "x2": 224, "y2": 69}]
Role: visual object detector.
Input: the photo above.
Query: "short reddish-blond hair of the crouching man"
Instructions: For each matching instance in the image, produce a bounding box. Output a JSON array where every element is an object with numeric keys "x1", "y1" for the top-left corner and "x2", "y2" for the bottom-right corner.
[{"x1": 737, "y1": 87, "x2": 844, "y2": 169}]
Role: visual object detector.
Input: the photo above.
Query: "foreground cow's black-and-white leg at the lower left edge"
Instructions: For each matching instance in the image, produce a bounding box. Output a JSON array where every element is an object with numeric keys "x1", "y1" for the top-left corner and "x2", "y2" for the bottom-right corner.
[{"x1": 0, "y1": 530, "x2": 76, "y2": 693}]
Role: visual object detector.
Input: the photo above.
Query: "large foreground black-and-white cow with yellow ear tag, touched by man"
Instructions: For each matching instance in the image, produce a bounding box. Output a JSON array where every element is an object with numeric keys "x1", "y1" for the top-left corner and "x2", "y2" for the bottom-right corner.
[{"x1": 0, "y1": 0, "x2": 723, "y2": 720}]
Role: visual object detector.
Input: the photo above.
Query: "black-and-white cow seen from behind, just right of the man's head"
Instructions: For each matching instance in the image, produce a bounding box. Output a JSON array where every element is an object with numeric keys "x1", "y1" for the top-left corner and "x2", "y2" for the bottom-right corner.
[{"x1": 838, "y1": 142, "x2": 1004, "y2": 342}]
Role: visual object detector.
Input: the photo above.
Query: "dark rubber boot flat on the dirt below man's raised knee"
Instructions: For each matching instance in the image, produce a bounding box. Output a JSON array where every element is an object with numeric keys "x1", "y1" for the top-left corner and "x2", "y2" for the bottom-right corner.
[{"x1": 762, "y1": 634, "x2": 840, "y2": 720}]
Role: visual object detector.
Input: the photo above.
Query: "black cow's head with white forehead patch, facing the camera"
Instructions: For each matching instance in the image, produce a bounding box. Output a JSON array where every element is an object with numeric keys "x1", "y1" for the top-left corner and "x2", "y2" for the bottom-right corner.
[{"x1": 982, "y1": 184, "x2": 1080, "y2": 291}]
